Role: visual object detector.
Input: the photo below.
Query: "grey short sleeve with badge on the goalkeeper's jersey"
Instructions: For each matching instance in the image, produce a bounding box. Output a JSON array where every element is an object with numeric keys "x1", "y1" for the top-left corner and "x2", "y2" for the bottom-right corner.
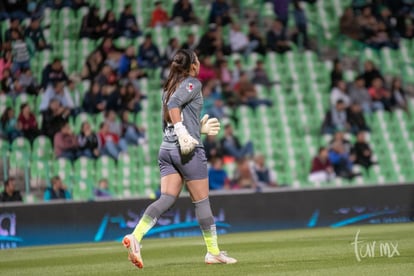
[{"x1": 167, "y1": 78, "x2": 201, "y2": 110}]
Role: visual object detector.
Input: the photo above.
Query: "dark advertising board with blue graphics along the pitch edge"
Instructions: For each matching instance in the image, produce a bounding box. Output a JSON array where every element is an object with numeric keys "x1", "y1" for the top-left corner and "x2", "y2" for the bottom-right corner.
[{"x1": 0, "y1": 185, "x2": 414, "y2": 249}]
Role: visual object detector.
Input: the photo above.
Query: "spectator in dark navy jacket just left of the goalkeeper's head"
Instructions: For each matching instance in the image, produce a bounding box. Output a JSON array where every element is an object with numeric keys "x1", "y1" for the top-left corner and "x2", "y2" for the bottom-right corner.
[{"x1": 138, "y1": 33, "x2": 161, "y2": 69}]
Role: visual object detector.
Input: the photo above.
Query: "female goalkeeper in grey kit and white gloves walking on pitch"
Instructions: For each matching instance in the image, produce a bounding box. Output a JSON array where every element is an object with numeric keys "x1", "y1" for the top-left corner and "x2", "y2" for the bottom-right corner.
[{"x1": 122, "y1": 50, "x2": 237, "y2": 268}]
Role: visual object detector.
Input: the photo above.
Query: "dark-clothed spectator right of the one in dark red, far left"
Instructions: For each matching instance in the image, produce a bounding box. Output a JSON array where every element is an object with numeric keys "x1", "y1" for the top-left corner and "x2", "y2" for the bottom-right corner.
[{"x1": 41, "y1": 99, "x2": 70, "y2": 141}]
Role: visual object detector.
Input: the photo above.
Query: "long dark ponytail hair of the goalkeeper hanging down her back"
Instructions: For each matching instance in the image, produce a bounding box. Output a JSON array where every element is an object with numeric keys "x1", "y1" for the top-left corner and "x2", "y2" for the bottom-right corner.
[{"x1": 163, "y1": 49, "x2": 196, "y2": 122}]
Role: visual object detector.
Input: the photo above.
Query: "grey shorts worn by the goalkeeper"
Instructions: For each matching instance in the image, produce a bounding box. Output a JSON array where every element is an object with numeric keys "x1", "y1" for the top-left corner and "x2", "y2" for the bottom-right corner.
[{"x1": 158, "y1": 147, "x2": 208, "y2": 181}]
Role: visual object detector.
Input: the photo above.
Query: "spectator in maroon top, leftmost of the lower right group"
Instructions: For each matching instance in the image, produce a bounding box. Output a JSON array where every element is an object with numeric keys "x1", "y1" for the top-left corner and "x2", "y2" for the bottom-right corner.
[{"x1": 308, "y1": 147, "x2": 335, "y2": 182}]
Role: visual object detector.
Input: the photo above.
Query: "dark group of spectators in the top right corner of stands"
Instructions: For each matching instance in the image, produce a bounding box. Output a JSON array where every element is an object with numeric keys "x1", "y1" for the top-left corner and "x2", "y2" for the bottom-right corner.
[{"x1": 339, "y1": 0, "x2": 414, "y2": 49}]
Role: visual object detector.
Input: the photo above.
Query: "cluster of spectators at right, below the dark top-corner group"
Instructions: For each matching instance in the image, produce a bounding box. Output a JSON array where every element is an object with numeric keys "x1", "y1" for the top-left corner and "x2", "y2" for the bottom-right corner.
[{"x1": 308, "y1": 56, "x2": 410, "y2": 182}]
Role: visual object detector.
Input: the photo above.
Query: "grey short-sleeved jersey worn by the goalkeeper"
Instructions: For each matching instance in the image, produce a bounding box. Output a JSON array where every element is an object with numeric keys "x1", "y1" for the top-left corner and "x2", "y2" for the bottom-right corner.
[{"x1": 161, "y1": 77, "x2": 203, "y2": 149}]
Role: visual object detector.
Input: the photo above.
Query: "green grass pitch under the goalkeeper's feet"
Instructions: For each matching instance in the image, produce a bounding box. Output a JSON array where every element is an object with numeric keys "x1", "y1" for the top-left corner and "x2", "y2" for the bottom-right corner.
[{"x1": 0, "y1": 223, "x2": 414, "y2": 276}]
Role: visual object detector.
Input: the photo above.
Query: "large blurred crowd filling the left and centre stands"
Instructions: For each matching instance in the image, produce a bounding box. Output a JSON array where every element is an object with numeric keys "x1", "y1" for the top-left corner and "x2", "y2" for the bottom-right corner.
[{"x1": 0, "y1": 0, "x2": 309, "y2": 201}]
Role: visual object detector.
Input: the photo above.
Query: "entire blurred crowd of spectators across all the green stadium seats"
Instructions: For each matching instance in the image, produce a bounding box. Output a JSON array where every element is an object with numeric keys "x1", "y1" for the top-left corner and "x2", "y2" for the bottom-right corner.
[{"x1": 0, "y1": 0, "x2": 413, "y2": 201}]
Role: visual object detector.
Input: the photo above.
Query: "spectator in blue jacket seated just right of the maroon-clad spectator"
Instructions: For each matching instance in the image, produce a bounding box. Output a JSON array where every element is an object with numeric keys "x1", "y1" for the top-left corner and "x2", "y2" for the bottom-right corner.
[{"x1": 329, "y1": 142, "x2": 354, "y2": 179}]
